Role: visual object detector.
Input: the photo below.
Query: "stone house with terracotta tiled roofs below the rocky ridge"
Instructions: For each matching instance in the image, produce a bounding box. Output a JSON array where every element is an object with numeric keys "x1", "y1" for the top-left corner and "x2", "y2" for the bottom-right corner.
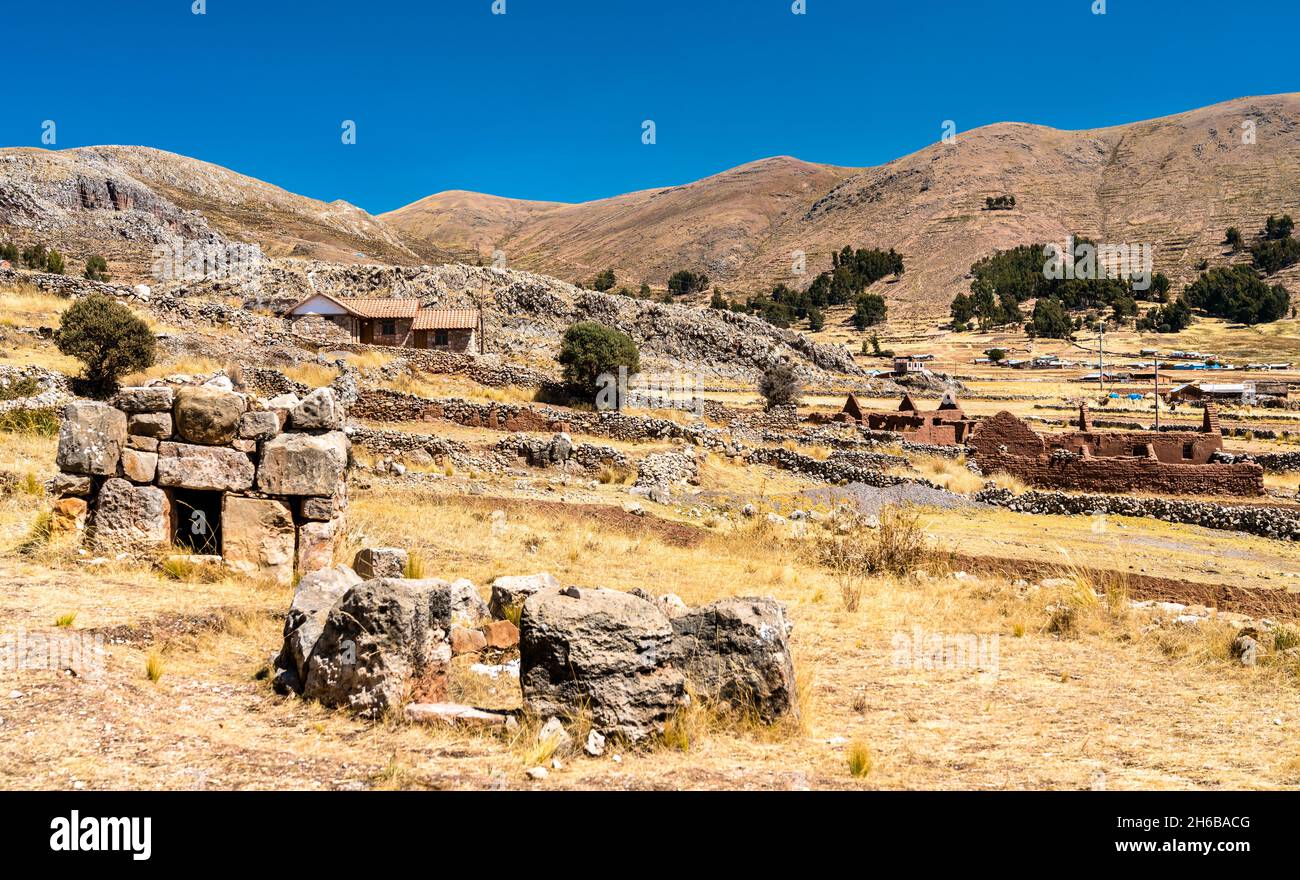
[{"x1": 285, "y1": 294, "x2": 484, "y2": 355}]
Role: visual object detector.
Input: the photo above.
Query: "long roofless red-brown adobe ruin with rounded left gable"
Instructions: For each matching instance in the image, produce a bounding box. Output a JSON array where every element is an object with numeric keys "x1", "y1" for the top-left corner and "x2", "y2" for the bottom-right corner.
[{"x1": 969, "y1": 403, "x2": 1264, "y2": 497}]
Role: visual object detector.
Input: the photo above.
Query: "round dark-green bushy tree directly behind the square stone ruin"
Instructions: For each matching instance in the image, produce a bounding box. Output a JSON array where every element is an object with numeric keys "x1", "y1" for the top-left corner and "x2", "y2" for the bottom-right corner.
[{"x1": 55, "y1": 294, "x2": 155, "y2": 399}]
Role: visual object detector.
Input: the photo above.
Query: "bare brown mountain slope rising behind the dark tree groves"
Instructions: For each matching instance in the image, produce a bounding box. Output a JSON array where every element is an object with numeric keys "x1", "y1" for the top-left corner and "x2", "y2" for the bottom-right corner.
[{"x1": 381, "y1": 94, "x2": 1300, "y2": 315}]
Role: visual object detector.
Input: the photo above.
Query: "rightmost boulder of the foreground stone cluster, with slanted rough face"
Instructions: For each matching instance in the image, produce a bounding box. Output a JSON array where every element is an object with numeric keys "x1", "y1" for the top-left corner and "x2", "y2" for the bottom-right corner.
[{"x1": 672, "y1": 598, "x2": 798, "y2": 723}]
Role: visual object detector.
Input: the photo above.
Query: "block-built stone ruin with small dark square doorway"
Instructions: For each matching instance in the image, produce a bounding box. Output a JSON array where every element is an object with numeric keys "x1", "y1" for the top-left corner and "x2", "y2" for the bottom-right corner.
[{"x1": 49, "y1": 380, "x2": 351, "y2": 584}]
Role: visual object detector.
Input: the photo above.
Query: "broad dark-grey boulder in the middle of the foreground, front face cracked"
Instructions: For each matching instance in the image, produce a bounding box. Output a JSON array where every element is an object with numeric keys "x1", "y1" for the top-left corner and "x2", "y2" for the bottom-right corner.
[{"x1": 519, "y1": 588, "x2": 685, "y2": 742}]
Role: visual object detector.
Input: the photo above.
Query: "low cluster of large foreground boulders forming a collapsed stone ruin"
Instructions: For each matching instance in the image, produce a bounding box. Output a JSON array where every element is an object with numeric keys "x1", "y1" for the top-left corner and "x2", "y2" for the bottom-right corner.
[{"x1": 276, "y1": 566, "x2": 798, "y2": 738}]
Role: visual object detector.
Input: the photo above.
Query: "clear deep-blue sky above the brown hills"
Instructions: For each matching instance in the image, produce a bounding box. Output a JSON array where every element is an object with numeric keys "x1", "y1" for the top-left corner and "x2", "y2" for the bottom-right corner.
[{"x1": 0, "y1": 0, "x2": 1300, "y2": 213}]
